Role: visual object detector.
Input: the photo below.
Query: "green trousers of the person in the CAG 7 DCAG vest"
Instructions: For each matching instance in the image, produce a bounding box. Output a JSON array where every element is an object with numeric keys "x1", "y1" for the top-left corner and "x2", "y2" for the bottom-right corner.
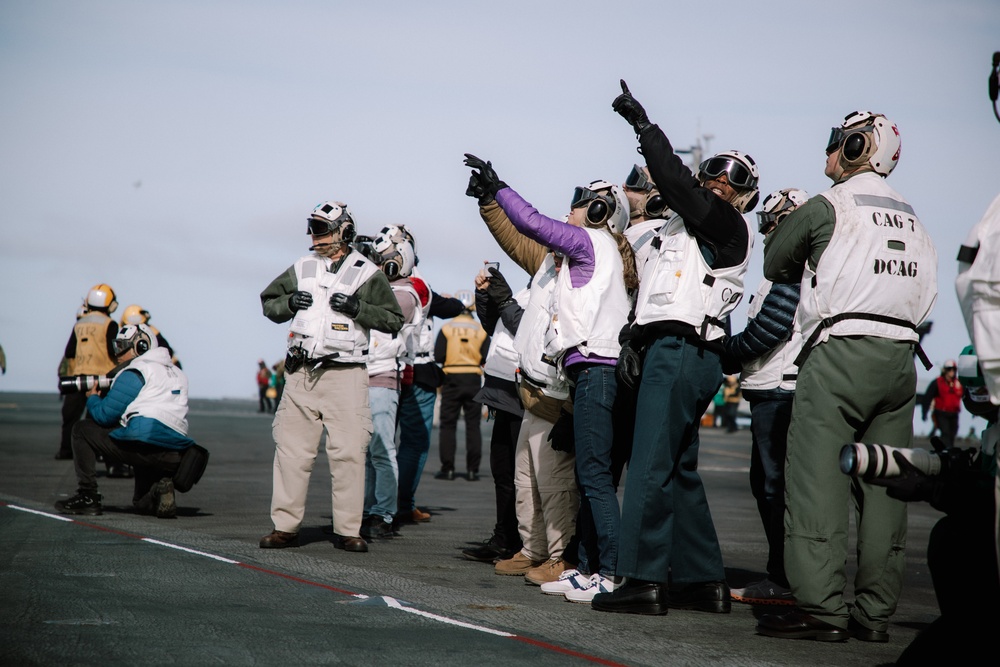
[{"x1": 785, "y1": 336, "x2": 917, "y2": 631}]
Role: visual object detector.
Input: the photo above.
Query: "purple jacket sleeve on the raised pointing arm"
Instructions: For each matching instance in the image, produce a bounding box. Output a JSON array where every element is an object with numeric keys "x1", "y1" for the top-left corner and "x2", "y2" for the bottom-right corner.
[{"x1": 496, "y1": 188, "x2": 594, "y2": 287}]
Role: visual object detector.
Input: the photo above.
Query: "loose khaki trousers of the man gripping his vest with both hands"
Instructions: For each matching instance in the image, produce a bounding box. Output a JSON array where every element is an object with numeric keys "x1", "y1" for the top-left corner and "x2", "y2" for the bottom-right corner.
[{"x1": 271, "y1": 366, "x2": 372, "y2": 537}]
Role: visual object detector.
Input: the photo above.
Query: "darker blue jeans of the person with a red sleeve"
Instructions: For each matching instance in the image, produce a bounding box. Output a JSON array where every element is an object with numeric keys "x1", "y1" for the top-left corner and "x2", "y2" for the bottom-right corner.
[{"x1": 396, "y1": 384, "x2": 437, "y2": 513}]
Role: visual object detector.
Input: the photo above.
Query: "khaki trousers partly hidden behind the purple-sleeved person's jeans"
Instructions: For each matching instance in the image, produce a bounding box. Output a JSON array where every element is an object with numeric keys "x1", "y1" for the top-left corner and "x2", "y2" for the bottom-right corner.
[{"x1": 514, "y1": 410, "x2": 580, "y2": 561}]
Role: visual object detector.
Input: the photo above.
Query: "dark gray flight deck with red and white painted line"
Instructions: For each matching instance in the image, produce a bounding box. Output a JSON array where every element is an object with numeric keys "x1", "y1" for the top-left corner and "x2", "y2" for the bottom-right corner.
[{"x1": 0, "y1": 393, "x2": 940, "y2": 667}]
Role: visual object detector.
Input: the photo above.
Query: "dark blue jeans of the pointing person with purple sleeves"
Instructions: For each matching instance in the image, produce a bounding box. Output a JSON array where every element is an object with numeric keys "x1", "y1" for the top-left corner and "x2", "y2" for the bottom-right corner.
[{"x1": 566, "y1": 364, "x2": 621, "y2": 577}]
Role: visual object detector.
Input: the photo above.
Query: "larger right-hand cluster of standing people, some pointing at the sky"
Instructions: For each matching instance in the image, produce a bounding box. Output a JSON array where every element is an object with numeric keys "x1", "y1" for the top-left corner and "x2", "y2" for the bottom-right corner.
[{"x1": 454, "y1": 82, "x2": 937, "y2": 641}]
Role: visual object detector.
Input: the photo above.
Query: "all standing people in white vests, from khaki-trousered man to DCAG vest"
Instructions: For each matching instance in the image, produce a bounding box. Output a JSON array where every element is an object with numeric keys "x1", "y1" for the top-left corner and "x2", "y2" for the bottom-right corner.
[{"x1": 244, "y1": 82, "x2": 960, "y2": 641}]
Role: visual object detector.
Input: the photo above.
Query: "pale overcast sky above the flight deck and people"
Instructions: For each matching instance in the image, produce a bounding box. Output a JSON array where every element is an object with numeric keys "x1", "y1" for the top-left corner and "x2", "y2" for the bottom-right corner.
[{"x1": 0, "y1": 0, "x2": 1000, "y2": 436}]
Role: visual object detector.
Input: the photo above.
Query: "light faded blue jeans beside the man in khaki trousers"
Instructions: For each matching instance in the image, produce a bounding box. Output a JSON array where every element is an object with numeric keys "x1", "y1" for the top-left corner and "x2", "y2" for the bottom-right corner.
[{"x1": 364, "y1": 387, "x2": 399, "y2": 523}]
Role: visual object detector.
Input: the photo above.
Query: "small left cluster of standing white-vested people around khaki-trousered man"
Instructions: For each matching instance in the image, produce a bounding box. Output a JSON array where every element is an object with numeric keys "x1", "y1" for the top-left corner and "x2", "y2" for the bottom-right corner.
[{"x1": 260, "y1": 201, "x2": 478, "y2": 552}]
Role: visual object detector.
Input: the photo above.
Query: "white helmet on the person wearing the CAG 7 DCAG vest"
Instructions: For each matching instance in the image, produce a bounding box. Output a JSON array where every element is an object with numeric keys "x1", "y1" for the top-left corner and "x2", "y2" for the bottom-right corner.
[{"x1": 826, "y1": 111, "x2": 901, "y2": 176}]
